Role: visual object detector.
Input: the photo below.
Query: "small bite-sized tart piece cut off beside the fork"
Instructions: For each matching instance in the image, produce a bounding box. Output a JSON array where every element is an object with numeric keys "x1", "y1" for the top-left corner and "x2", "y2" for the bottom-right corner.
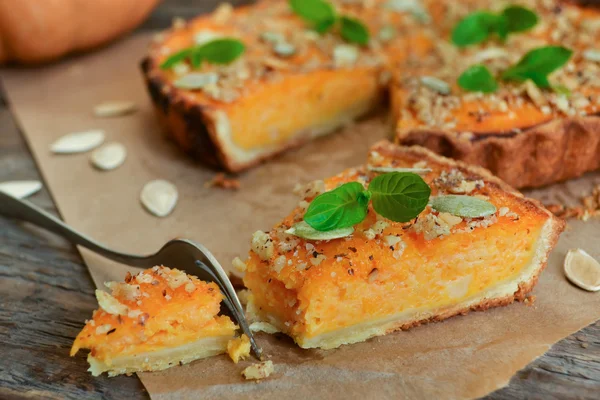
[{"x1": 71, "y1": 267, "x2": 237, "y2": 376}]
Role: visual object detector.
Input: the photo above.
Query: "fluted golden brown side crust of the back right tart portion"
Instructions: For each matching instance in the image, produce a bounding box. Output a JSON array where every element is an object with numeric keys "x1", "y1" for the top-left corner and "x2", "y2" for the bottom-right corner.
[{"x1": 397, "y1": 116, "x2": 600, "y2": 188}]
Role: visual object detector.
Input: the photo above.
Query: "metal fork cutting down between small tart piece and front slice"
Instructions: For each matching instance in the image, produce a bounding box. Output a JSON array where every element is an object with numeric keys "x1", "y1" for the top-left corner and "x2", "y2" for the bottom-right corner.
[{"x1": 0, "y1": 192, "x2": 262, "y2": 359}]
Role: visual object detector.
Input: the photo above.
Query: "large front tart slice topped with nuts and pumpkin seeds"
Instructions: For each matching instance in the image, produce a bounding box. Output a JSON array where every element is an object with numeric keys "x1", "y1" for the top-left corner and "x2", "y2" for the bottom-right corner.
[{"x1": 244, "y1": 142, "x2": 564, "y2": 349}]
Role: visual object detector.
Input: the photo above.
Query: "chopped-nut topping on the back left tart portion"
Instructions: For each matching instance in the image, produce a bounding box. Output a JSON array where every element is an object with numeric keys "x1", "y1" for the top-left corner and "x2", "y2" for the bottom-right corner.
[{"x1": 152, "y1": 0, "x2": 422, "y2": 103}]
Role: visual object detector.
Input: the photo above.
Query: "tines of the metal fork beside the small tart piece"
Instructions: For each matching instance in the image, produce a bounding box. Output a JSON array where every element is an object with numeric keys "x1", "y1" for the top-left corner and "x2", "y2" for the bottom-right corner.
[{"x1": 196, "y1": 260, "x2": 262, "y2": 360}]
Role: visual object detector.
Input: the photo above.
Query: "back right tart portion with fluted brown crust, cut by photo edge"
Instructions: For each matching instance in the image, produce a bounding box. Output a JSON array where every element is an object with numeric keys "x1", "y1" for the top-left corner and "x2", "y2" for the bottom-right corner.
[{"x1": 391, "y1": 0, "x2": 600, "y2": 188}]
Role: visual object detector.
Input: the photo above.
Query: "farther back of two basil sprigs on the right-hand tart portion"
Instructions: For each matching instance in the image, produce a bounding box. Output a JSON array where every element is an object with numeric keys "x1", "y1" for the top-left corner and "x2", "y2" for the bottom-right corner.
[{"x1": 452, "y1": 5, "x2": 538, "y2": 47}]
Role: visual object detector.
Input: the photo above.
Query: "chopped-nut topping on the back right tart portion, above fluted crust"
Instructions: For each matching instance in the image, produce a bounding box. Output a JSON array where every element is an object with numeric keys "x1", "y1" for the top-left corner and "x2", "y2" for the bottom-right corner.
[{"x1": 396, "y1": 0, "x2": 600, "y2": 133}]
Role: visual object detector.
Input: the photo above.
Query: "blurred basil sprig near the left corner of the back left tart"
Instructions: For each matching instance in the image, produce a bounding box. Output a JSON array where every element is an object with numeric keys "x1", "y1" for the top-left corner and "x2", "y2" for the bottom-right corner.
[{"x1": 160, "y1": 38, "x2": 246, "y2": 69}]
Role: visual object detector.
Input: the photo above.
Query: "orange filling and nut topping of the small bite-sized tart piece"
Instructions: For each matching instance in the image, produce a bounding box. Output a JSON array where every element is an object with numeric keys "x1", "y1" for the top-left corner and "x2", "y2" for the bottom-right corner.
[{"x1": 71, "y1": 266, "x2": 235, "y2": 357}]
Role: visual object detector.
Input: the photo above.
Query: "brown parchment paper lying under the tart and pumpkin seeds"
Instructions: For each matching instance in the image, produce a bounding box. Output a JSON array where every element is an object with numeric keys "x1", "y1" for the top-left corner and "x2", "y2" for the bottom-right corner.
[{"x1": 1, "y1": 36, "x2": 600, "y2": 400}]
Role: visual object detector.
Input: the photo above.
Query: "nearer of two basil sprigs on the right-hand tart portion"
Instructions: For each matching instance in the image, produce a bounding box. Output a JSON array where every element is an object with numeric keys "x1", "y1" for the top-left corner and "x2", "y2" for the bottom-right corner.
[{"x1": 457, "y1": 46, "x2": 573, "y2": 93}]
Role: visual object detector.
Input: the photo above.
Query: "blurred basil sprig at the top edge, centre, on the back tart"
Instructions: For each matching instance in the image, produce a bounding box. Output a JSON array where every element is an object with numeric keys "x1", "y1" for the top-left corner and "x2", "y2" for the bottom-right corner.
[{"x1": 289, "y1": 0, "x2": 370, "y2": 46}]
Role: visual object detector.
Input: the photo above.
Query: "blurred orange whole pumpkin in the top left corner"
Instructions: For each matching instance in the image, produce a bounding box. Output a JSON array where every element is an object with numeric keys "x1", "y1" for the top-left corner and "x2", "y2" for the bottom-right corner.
[{"x1": 0, "y1": 0, "x2": 160, "y2": 64}]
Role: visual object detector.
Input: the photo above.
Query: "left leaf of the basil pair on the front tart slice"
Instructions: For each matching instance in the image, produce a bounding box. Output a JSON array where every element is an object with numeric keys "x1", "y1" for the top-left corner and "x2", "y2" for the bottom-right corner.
[{"x1": 304, "y1": 182, "x2": 370, "y2": 231}]
